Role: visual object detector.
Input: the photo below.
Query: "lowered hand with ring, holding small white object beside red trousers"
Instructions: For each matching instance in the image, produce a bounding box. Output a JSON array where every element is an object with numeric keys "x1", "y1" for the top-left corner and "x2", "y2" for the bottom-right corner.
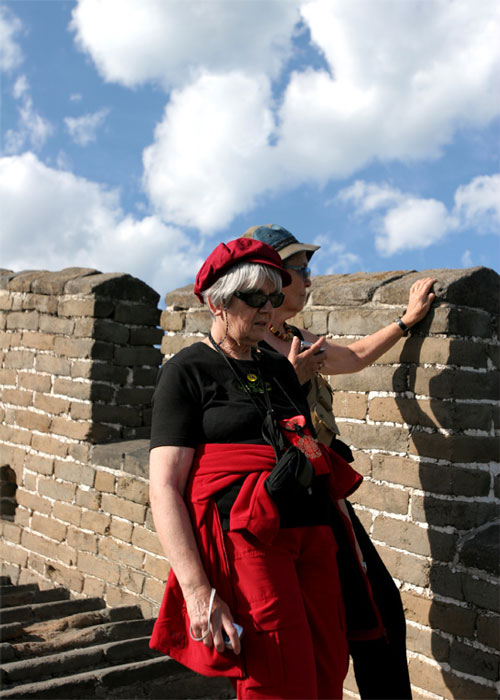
[{"x1": 184, "y1": 586, "x2": 241, "y2": 654}]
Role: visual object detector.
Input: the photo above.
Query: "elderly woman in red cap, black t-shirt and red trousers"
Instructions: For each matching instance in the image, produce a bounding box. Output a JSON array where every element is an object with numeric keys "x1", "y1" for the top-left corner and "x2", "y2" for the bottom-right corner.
[{"x1": 150, "y1": 238, "x2": 380, "y2": 698}]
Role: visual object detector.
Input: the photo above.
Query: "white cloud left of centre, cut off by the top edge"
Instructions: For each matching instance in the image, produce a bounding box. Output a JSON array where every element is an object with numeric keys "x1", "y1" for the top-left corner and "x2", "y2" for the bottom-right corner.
[{"x1": 71, "y1": 0, "x2": 300, "y2": 87}]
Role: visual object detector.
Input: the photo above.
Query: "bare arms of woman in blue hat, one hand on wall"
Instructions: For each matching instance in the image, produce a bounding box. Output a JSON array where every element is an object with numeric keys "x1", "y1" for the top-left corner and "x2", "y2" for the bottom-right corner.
[{"x1": 288, "y1": 277, "x2": 436, "y2": 382}]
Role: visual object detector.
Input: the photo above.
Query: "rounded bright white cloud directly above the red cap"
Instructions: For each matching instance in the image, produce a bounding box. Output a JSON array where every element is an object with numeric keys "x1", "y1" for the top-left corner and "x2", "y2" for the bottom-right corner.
[{"x1": 143, "y1": 73, "x2": 273, "y2": 231}]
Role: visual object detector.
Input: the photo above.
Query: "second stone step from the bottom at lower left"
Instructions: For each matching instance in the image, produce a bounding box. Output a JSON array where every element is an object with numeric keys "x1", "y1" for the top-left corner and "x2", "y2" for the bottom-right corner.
[{"x1": 0, "y1": 636, "x2": 159, "y2": 689}]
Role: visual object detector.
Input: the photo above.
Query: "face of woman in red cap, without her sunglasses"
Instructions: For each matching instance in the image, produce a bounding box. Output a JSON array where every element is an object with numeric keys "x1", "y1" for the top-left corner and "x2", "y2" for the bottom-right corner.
[{"x1": 221, "y1": 282, "x2": 276, "y2": 345}]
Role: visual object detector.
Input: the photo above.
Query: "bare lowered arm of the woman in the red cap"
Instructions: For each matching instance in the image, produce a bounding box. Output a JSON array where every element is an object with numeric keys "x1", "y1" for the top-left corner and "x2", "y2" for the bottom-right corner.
[{"x1": 149, "y1": 446, "x2": 240, "y2": 654}]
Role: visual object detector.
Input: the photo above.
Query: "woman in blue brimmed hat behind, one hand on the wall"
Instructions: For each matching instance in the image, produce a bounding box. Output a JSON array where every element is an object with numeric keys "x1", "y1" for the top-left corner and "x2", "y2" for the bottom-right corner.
[{"x1": 244, "y1": 224, "x2": 435, "y2": 700}]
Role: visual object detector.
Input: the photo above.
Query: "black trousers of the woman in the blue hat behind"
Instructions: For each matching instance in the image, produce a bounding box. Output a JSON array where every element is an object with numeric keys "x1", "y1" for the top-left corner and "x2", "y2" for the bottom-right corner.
[{"x1": 347, "y1": 503, "x2": 411, "y2": 700}]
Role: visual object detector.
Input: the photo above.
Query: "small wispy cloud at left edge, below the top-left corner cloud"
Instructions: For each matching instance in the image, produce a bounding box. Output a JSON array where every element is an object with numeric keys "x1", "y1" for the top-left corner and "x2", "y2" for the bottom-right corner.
[{"x1": 4, "y1": 75, "x2": 54, "y2": 154}]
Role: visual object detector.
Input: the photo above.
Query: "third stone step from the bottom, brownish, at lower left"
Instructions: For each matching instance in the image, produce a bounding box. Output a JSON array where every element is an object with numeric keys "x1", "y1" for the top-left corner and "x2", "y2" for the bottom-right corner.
[{"x1": 13, "y1": 608, "x2": 154, "y2": 659}]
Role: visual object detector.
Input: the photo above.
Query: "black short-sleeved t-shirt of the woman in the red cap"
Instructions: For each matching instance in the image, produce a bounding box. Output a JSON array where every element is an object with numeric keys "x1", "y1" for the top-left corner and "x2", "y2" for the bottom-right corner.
[{"x1": 151, "y1": 343, "x2": 312, "y2": 448}]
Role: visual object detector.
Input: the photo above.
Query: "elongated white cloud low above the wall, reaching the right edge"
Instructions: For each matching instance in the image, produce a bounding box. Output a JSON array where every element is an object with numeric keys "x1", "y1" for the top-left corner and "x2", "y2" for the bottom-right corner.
[{"x1": 337, "y1": 175, "x2": 500, "y2": 256}]
